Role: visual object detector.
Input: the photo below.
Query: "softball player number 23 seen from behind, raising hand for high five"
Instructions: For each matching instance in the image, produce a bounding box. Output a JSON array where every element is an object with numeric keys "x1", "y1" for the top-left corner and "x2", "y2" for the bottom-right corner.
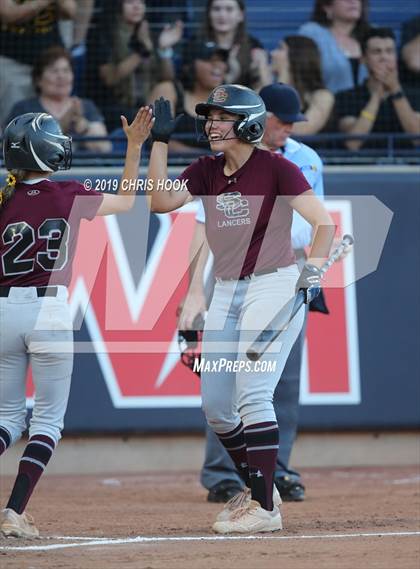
[{"x1": 0, "y1": 107, "x2": 153, "y2": 538}]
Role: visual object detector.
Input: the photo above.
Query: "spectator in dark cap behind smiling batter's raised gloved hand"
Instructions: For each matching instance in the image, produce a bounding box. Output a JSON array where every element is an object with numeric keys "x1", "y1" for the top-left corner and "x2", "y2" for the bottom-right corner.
[{"x1": 150, "y1": 42, "x2": 228, "y2": 154}]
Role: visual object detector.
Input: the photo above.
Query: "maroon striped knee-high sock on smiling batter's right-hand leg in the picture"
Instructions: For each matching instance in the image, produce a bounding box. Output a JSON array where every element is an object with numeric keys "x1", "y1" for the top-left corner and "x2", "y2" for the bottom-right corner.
[{"x1": 244, "y1": 421, "x2": 279, "y2": 511}]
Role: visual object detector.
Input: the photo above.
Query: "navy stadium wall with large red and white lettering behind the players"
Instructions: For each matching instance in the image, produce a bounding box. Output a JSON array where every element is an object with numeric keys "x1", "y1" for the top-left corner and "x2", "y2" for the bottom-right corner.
[{"x1": 2, "y1": 166, "x2": 420, "y2": 433}]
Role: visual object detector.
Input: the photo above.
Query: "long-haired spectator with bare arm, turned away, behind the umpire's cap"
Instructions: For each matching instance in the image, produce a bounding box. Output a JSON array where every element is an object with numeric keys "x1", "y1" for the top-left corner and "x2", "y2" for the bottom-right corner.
[{"x1": 271, "y1": 35, "x2": 334, "y2": 136}]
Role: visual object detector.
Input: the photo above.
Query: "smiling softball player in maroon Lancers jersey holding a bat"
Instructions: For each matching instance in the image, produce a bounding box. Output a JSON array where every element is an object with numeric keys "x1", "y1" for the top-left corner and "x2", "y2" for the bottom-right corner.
[{"x1": 148, "y1": 85, "x2": 335, "y2": 533}]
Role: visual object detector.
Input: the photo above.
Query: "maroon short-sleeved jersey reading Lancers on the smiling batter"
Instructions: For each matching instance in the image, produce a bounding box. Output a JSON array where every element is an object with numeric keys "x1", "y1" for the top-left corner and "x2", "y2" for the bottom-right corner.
[{"x1": 180, "y1": 148, "x2": 311, "y2": 278}]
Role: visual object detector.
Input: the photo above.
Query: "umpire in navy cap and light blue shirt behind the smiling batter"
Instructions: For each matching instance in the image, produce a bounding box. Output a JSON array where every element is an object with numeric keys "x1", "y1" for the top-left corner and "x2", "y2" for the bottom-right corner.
[{"x1": 179, "y1": 83, "x2": 324, "y2": 502}]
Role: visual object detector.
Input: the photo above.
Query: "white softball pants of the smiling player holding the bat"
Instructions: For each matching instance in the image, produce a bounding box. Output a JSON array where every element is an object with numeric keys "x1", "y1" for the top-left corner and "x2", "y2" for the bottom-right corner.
[{"x1": 201, "y1": 265, "x2": 304, "y2": 433}]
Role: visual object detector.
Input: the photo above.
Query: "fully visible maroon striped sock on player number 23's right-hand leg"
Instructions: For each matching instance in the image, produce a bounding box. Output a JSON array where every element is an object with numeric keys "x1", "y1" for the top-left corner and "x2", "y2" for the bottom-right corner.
[{"x1": 6, "y1": 435, "x2": 55, "y2": 514}]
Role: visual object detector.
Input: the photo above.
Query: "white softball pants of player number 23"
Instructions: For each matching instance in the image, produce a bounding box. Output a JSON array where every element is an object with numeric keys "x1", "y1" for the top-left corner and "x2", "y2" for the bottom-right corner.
[{"x1": 0, "y1": 286, "x2": 73, "y2": 443}]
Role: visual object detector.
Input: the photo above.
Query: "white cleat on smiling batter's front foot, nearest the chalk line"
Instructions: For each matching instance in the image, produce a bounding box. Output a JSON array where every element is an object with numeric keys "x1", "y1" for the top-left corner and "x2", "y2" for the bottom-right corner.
[{"x1": 213, "y1": 500, "x2": 283, "y2": 534}]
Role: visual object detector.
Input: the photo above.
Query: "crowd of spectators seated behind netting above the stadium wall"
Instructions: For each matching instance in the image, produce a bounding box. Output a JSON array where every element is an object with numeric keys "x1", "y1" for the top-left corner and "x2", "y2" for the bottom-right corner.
[{"x1": 0, "y1": 0, "x2": 420, "y2": 154}]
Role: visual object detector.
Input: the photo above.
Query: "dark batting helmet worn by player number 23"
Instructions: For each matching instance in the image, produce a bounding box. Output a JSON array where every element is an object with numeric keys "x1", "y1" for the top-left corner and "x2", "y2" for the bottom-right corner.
[{"x1": 3, "y1": 113, "x2": 72, "y2": 172}]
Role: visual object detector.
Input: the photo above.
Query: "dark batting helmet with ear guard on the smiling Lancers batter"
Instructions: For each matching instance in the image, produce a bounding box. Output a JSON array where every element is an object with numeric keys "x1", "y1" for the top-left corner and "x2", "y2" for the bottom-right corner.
[{"x1": 195, "y1": 85, "x2": 267, "y2": 144}]
